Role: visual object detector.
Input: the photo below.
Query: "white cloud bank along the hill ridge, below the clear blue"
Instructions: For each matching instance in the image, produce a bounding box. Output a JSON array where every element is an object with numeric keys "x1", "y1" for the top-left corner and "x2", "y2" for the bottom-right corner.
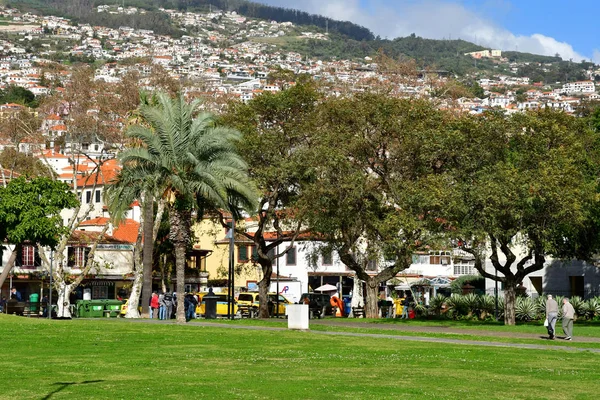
[{"x1": 259, "y1": 0, "x2": 584, "y2": 61}]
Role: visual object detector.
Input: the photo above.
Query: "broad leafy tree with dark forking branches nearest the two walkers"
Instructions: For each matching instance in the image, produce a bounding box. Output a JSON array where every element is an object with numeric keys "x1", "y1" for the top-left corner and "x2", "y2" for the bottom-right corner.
[{"x1": 446, "y1": 110, "x2": 599, "y2": 324}]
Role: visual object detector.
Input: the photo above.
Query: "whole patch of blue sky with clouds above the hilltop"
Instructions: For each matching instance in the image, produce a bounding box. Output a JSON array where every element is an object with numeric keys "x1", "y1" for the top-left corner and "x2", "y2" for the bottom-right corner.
[{"x1": 254, "y1": 0, "x2": 600, "y2": 63}]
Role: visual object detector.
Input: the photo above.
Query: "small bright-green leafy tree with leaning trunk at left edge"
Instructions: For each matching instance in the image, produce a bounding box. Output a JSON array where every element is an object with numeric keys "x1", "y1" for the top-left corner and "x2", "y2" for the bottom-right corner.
[{"x1": 0, "y1": 177, "x2": 79, "y2": 287}]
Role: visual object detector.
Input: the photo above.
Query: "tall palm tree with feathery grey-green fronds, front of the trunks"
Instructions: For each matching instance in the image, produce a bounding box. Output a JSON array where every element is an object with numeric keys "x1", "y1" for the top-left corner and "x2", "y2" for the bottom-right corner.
[{"x1": 113, "y1": 93, "x2": 257, "y2": 322}]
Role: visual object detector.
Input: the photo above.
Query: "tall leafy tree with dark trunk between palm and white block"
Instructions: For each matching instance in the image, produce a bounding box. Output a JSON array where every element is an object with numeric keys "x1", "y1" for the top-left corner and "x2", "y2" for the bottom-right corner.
[{"x1": 222, "y1": 77, "x2": 321, "y2": 318}]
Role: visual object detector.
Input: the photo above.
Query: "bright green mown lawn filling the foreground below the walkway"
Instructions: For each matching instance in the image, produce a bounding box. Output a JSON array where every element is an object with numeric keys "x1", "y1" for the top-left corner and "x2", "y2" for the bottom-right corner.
[{"x1": 0, "y1": 315, "x2": 600, "y2": 400}]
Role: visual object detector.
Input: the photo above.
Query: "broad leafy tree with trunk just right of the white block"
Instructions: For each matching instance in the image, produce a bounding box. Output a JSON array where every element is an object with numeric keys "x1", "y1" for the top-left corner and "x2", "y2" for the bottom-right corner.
[{"x1": 302, "y1": 93, "x2": 458, "y2": 318}]
